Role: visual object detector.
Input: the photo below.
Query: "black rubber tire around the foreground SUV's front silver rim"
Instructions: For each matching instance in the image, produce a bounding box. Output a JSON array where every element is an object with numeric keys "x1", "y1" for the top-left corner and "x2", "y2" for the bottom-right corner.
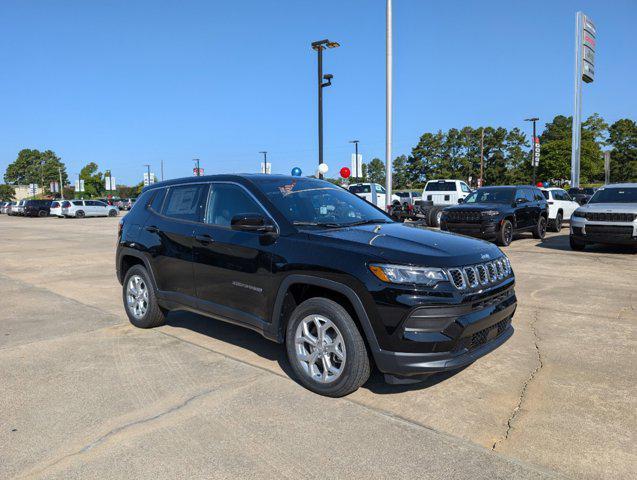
[{"x1": 285, "y1": 297, "x2": 371, "y2": 397}]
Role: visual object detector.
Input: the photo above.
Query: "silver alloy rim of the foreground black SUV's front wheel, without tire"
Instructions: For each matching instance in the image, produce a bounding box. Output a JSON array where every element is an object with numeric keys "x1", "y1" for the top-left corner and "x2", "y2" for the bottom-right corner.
[{"x1": 294, "y1": 315, "x2": 346, "y2": 384}]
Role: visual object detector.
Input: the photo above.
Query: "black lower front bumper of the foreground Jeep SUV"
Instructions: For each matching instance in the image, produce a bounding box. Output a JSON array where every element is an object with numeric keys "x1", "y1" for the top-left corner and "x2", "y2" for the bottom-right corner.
[{"x1": 374, "y1": 286, "x2": 517, "y2": 376}]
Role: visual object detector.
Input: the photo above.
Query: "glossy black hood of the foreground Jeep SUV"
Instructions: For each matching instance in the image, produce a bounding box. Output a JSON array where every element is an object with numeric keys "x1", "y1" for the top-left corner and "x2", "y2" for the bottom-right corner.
[{"x1": 307, "y1": 223, "x2": 503, "y2": 267}]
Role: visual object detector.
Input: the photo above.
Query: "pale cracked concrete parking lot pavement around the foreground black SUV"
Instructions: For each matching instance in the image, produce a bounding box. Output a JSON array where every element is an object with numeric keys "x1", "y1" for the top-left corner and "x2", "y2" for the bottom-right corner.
[{"x1": 0, "y1": 215, "x2": 637, "y2": 479}]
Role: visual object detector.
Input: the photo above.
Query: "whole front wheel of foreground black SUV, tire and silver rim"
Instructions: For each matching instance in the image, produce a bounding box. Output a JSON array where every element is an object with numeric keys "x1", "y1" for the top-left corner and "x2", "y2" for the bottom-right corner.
[{"x1": 285, "y1": 298, "x2": 371, "y2": 397}]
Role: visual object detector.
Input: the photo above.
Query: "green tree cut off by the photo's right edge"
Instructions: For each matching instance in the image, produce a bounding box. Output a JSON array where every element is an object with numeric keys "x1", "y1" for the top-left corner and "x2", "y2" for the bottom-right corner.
[{"x1": 608, "y1": 118, "x2": 637, "y2": 182}]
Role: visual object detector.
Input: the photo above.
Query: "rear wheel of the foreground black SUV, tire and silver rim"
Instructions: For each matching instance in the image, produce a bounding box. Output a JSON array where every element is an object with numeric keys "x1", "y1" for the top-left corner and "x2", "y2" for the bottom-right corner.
[{"x1": 122, "y1": 265, "x2": 166, "y2": 328}]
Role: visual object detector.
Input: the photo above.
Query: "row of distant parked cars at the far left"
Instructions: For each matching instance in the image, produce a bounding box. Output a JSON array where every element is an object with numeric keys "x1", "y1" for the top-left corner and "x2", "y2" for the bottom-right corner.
[{"x1": 0, "y1": 200, "x2": 119, "y2": 218}]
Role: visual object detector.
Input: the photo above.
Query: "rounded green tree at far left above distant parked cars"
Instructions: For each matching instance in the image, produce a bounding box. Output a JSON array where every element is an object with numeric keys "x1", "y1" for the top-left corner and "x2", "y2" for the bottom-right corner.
[{"x1": 4, "y1": 148, "x2": 68, "y2": 191}]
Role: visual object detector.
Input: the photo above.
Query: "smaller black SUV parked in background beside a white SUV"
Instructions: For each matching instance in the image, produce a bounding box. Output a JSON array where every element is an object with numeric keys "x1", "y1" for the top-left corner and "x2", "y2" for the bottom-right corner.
[{"x1": 440, "y1": 186, "x2": 549, "y2": 246}]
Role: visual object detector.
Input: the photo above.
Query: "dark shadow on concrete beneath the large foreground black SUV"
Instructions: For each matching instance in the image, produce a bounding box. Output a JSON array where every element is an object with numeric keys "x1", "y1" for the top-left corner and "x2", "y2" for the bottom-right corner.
[{"x1": 166, "y1": 311, "x2": 460, "y2": 394}]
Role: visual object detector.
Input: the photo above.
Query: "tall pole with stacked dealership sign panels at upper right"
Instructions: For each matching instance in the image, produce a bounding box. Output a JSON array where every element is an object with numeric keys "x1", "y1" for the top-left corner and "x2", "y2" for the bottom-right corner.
[{"x1": 571, "y1": 12, "x2": 597, "y2": 187}]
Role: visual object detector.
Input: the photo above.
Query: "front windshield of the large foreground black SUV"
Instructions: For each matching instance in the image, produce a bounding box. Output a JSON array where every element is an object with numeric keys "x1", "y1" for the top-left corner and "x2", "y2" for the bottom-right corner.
[{"x1": 256, "y1": 177, "x2": 392, "y2": 227}]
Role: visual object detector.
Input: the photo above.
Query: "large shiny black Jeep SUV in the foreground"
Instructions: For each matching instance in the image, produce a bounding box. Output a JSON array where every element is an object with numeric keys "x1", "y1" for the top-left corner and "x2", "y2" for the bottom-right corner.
[{"x1": 116, "y1": 175, "x2": 517, "y2": 396}]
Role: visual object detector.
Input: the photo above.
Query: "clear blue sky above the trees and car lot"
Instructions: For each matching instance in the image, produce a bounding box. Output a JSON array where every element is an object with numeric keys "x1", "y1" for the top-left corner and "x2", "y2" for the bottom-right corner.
[{"x1": 0, "y1": 0, "x2": 637, "y2": 184}]
